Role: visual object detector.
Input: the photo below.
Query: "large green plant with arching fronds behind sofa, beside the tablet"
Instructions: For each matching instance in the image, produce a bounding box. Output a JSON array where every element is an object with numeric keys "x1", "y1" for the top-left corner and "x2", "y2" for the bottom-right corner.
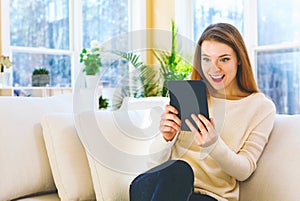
[{"x1": 108, "y1": 21, "x2": 193, "y2": 109}]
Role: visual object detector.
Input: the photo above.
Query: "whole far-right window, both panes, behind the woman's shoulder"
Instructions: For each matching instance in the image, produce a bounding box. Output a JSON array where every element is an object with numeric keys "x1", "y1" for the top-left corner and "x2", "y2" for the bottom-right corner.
[{"x1": 255, "y1": 0, "x2": 300, "y2": 114}]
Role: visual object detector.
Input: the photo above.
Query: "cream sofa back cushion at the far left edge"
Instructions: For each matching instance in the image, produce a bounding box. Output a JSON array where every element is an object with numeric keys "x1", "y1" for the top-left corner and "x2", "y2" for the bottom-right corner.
[{"x1": 0, "y1": 94, "x2": 73, "y2": 200}]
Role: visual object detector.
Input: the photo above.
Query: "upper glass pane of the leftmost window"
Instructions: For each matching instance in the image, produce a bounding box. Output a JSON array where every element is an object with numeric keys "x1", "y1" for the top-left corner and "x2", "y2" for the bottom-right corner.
[{"x1": 10, "y1": 0, "x2": 69, "y2": 50}]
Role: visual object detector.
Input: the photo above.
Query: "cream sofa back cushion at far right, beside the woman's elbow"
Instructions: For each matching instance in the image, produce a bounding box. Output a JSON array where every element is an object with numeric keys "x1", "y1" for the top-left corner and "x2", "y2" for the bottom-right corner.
[{"x1": 240, "y1": 115, "x2": 300, "y2": 201}]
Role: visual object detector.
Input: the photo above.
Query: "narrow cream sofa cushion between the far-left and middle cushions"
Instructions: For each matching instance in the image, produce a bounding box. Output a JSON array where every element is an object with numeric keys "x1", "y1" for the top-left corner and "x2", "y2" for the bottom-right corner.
[{"x1": 42, "y1": 113, "x2": 96, "y2": 201}]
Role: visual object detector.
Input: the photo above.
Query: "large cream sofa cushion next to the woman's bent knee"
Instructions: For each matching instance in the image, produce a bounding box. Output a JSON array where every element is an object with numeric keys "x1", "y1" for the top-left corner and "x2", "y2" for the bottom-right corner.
[{"x1": 76, "y1": 107, "x2": 163, "y2": 201}]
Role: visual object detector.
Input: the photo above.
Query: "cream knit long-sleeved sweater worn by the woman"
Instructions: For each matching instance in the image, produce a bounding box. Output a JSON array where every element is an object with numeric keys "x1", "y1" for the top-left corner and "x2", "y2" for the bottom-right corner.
[{"x1": 153, "y1": 93, "x2": 275, "y2": 201}]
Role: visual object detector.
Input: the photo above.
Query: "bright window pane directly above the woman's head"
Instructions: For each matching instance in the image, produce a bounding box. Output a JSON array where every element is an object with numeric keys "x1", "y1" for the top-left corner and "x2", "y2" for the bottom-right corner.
[{"x1": 193, "y1": 0, "x2": 244, "y2": 41}]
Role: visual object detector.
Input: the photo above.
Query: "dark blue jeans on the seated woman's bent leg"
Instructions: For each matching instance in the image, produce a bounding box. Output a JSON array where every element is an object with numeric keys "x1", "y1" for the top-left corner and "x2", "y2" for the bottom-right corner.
[{"x1": 130, "y1": 160, "x2": 216, "y2": 201}]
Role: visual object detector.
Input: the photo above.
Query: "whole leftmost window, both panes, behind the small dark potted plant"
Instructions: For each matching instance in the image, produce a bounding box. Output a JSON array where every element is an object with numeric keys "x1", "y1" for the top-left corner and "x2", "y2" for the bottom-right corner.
[{"x1": 9, "y1": 0, "x2": 73, "y2": 86}]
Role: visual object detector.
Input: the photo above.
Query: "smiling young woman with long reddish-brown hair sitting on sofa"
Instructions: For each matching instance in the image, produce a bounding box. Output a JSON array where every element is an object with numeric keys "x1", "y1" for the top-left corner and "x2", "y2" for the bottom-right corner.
[{"x1": 130, "y1": 23, "x2": 275, "y2": 201}]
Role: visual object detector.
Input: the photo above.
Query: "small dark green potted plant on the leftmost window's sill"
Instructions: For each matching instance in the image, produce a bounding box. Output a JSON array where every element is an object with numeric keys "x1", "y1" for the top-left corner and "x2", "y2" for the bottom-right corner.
[{"x1": 32, "y1": 67, "x2": 50, "y2": 87}]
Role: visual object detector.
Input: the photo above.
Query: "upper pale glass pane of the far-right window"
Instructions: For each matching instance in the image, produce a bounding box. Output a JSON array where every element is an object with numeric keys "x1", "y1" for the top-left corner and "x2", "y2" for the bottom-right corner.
[{"x1": 257, "y1": 0, "x2": 300, "y2": 45}]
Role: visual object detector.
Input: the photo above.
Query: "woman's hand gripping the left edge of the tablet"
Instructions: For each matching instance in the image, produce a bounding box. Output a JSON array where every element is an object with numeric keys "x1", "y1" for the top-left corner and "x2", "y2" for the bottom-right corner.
[{"x1": 159, "y1": 105, "x2": 181, "y2": 141}]
